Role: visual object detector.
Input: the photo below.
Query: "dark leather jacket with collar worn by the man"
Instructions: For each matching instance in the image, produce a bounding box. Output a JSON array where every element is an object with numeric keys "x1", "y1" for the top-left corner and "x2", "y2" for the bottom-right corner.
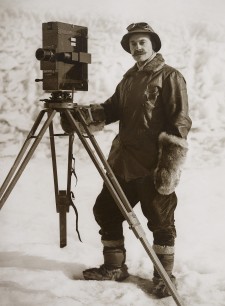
[{"x1": 102, "y1": 54, "x2": 191, "y2": 181}]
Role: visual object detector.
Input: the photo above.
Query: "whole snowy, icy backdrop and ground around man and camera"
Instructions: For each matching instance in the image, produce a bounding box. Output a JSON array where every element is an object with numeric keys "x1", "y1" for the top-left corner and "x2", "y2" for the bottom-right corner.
[{"x1": 0, "y1": 0, "x2": 225, "y2": 306}]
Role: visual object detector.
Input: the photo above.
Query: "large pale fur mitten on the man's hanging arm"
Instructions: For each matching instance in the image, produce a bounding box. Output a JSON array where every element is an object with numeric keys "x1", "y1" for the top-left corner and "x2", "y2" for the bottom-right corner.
[{"x1": 154, "y1": 132, "x2": 188, "y2": 195}]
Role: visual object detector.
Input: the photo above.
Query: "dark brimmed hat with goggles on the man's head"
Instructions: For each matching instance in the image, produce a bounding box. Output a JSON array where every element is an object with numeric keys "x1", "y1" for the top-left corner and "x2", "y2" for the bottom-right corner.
[{"x1": 120, "y1": 22, "x2": 161, "y2": 53}]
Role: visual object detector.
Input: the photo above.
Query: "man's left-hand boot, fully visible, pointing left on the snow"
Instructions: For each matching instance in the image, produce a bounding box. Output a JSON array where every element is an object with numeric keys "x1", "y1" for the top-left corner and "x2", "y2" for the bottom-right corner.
[{"x1": 83, "y1": 240, "x2": 129, "y2": 281}]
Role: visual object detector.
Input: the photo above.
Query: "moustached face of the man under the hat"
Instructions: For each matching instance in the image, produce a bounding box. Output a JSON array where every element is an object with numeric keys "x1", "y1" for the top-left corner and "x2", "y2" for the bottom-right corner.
[{"x1": 129, "y1": 33, "x2": 153, "y2": 62}]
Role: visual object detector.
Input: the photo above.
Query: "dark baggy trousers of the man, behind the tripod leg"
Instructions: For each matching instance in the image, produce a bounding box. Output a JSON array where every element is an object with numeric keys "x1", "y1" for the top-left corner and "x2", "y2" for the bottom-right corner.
[{"x1": 93, "y1": 176, "x2": 177, "y2": 246}]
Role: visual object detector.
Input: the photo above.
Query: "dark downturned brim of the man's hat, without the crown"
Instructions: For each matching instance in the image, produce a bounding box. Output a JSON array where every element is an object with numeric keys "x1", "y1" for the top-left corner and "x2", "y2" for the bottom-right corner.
[{"x1": 120, "y1": 29, "x2": 161, "y2": 53}]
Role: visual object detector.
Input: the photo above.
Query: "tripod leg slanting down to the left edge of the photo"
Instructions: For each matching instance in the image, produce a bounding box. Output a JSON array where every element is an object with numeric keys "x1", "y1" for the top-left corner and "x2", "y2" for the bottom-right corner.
[{"x1": 0, "y1": 110, "x2": 56, "y2": 209}]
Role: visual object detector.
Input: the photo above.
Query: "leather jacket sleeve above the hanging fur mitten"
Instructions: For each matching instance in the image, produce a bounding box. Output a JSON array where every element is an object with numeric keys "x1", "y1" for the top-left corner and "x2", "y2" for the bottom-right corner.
[{"x1": 162, "y1": 70, "x2": 192, "y2": 138}]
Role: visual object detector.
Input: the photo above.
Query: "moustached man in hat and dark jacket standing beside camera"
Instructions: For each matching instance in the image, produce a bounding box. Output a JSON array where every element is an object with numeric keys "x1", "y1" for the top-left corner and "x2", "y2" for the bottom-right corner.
[{"x1": 60, "y1": 23, "x2": 191, "y2": 297}]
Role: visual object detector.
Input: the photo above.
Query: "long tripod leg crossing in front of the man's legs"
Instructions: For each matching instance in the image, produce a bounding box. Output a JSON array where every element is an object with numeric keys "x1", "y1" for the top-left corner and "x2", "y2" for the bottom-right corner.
[{"x1": 65, "y1": 110, "x2": 182, "y2": 306}]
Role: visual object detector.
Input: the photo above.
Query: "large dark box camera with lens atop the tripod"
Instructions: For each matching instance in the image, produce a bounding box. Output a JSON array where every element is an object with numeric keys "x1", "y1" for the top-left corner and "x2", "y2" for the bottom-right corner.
[{"x1": 36, "y1": 22, "x2": 91, "y2": 92}]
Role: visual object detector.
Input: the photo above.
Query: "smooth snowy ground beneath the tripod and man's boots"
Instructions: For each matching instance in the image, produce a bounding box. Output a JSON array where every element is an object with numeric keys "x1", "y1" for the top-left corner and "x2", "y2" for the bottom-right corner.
[{"x1": 0, "y1": 157, "x2": 225, "y2": 306}]
